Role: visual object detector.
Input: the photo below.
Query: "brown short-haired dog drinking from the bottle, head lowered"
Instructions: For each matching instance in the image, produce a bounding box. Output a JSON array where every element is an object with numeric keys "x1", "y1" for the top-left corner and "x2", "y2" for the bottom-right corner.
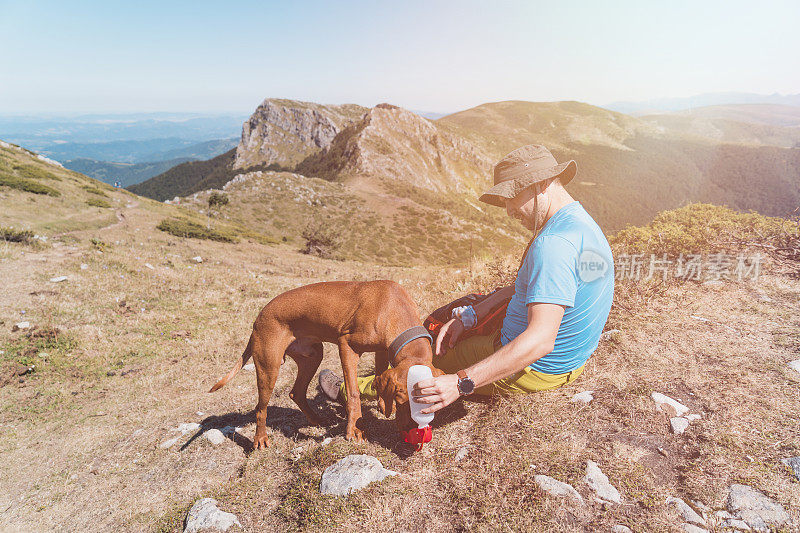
[{"x1": 209, "y1": 280, "x2": 441, "y2": 449}]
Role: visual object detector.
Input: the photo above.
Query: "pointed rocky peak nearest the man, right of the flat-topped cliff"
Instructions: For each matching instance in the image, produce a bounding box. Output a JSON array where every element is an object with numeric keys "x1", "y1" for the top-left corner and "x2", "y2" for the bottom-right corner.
[{"x1": 297, "y1": 104, "x2": 493, "y2": 192}]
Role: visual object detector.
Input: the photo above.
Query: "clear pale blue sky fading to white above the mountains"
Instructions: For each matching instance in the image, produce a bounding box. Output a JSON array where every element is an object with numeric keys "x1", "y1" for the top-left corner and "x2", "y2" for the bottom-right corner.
[{"x1": 0, "y1": 0, "x2": 800, "y2": 113}]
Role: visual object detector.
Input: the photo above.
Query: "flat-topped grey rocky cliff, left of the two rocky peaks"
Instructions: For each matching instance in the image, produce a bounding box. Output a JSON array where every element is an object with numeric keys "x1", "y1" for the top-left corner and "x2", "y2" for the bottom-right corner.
[{"x1": 233, "y1": 98, "x2": 367, "y2": 169}]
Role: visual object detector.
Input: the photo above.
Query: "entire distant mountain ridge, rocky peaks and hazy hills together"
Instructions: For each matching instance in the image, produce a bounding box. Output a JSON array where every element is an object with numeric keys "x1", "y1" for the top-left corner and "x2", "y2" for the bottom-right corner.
[{"x1": 131, "y1": 95, "x2": 800, "y2": 239}]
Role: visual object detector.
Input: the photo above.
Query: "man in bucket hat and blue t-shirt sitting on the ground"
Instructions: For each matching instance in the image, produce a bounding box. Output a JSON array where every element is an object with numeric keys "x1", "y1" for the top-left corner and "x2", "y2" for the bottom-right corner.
[{"x1": 320, "y1": 145, "x2": 614, "y2": 413}]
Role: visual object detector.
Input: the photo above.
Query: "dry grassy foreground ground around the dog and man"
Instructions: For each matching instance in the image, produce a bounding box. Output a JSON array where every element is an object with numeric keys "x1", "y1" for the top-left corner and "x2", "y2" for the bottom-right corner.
[{"x1": 0, "y1": 190, "x2": 800, "y2": 531}]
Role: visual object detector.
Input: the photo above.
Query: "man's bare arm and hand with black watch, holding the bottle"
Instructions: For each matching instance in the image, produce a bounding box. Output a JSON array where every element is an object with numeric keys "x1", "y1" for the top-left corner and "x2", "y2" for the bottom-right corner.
[{"x1": 412, "y1": 303, "x2": 564, "y2": 413}]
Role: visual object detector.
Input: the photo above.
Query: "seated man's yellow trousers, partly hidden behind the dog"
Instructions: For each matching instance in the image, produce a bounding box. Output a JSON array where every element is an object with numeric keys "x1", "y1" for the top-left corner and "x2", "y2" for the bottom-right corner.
[{"x1": 339, "y1": 331, "x2": 584, "y2": 398}]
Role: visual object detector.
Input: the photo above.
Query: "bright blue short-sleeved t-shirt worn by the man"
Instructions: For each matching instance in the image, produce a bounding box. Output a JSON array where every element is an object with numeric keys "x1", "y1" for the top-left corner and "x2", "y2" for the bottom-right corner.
[{"x1": 500, "y1": 202, "x2": 614, "y2": 374}]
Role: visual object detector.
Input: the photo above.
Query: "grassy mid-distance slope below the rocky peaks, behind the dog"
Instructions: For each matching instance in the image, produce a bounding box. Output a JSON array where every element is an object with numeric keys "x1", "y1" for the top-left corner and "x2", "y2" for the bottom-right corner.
[{"x1": 174, "y1": 171, "x2": 525, "y2": 266}]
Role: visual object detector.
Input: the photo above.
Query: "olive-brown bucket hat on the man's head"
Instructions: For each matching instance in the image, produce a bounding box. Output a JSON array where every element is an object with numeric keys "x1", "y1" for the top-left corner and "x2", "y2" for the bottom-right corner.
[{"x1": 479, "y1": 144, "x2": 578, "y2": 207}]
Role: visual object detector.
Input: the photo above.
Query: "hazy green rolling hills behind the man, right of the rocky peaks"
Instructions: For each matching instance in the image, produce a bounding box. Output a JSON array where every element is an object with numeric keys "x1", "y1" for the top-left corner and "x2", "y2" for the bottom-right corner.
[{"x1": 437, "y1": 102, "x2": 800, "y2": 232}]
